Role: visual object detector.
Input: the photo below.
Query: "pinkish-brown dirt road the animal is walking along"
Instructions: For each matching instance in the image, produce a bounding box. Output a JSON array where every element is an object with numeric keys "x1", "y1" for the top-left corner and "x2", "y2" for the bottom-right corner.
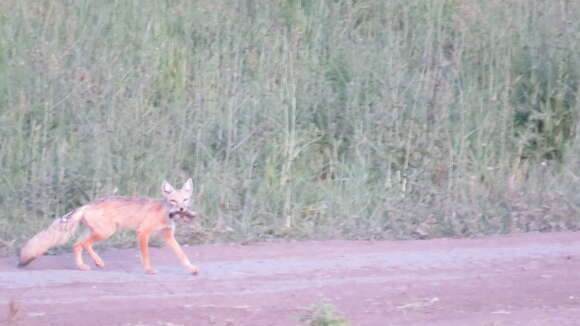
[{"x1": 0, "y1": 233, "x2": 580, "y2": 326}]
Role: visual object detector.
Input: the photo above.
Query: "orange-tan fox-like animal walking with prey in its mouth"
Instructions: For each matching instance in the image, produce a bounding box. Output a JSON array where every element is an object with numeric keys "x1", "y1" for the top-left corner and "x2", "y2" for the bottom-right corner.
[{"x1": 18, "y1": 178, "x2": 199, "y2": 275}]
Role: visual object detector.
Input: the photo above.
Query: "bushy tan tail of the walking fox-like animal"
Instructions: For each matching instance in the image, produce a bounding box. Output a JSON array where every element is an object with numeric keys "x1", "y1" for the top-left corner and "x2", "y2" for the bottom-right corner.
[{"x1": 18, "y1": 207, "x2": 83, "y2": 267}]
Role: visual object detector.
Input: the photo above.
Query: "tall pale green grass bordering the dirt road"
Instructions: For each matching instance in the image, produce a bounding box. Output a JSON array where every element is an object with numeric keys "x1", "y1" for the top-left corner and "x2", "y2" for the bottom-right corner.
[{"x1": 0, "y1": 0, "x2": 580, "y2": 250}]
